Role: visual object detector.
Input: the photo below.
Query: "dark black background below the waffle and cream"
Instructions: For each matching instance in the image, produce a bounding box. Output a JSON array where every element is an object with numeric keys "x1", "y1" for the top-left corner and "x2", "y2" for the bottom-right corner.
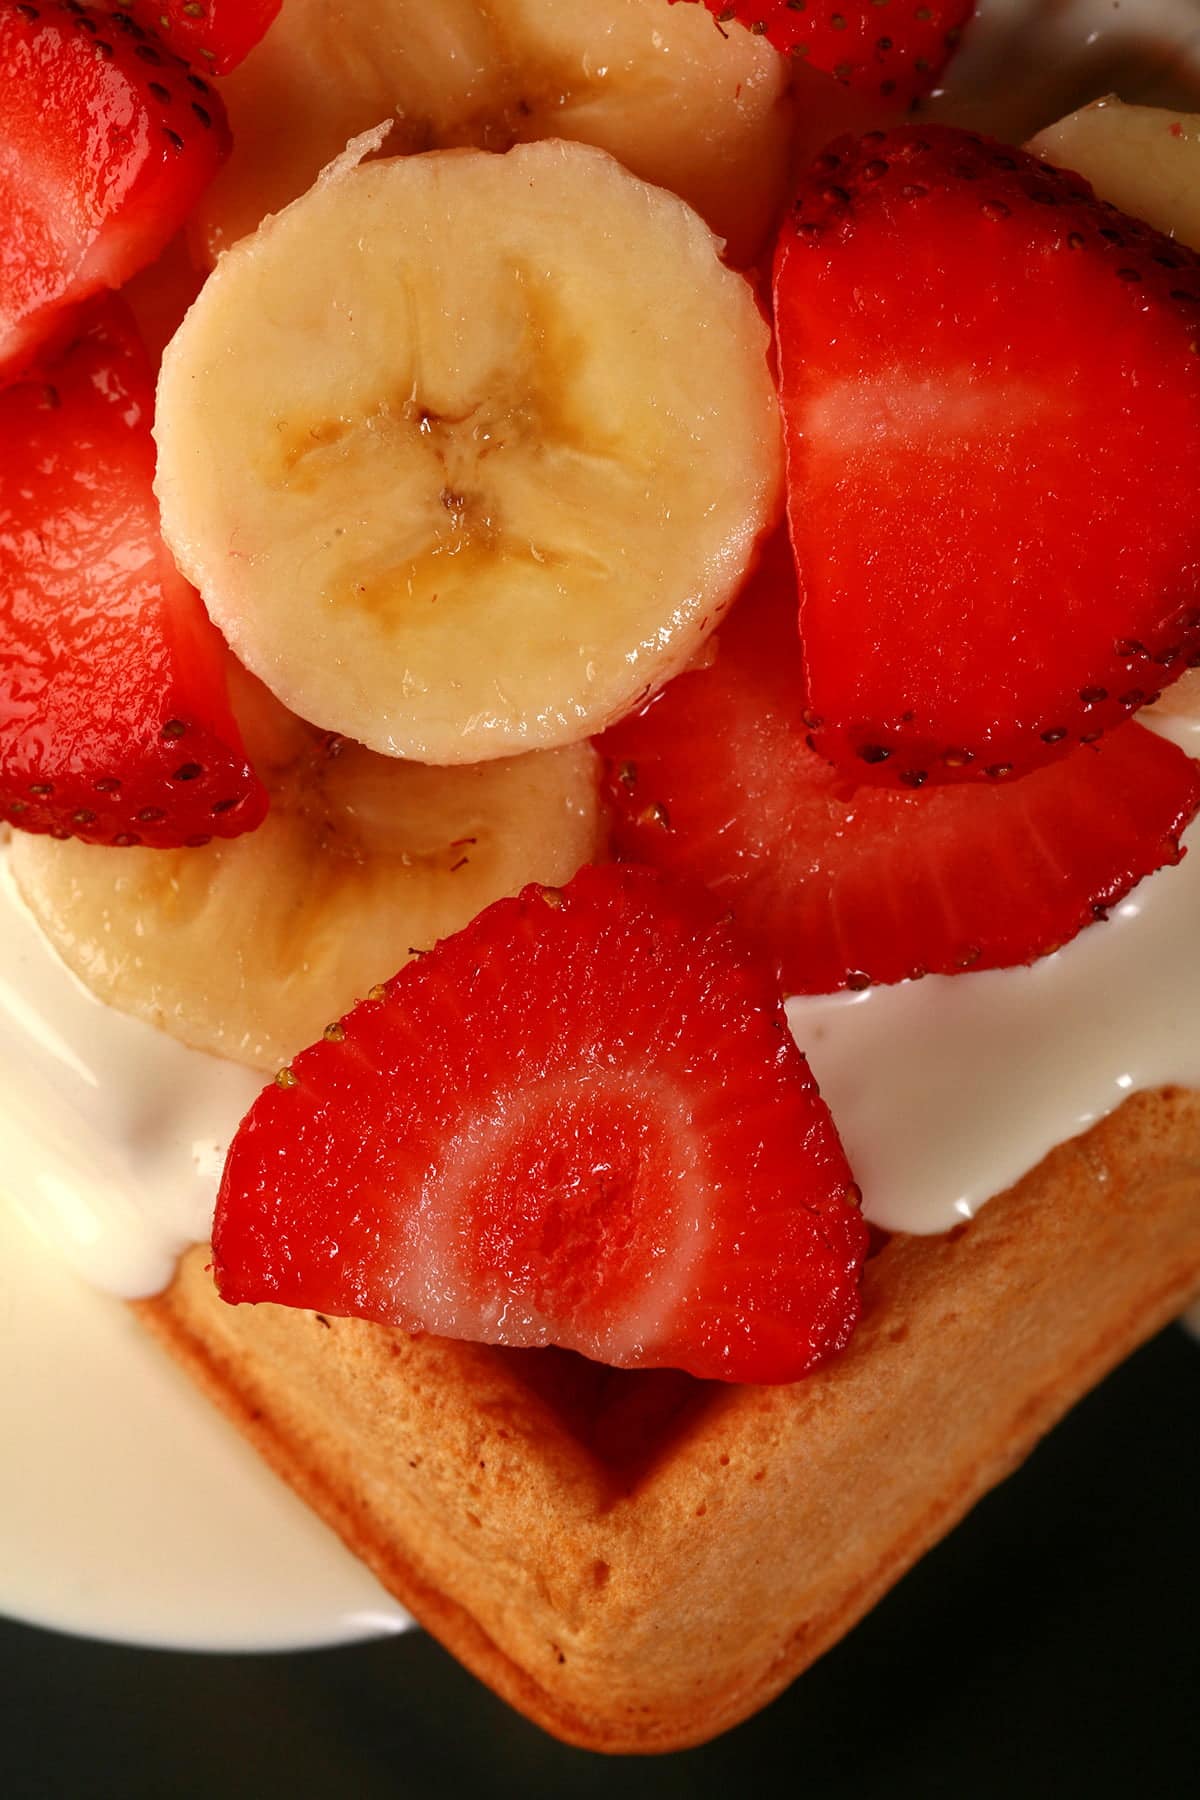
[{"x1": 0, "y1": 1328, "x2": 1200, "y2": 1800}]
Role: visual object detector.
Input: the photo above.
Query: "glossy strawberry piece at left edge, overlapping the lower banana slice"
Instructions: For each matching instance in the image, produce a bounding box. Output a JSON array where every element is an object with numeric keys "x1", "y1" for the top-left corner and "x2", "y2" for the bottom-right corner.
[{"x1": 0, "y1": 297, "x2": 266, "y2": 848}]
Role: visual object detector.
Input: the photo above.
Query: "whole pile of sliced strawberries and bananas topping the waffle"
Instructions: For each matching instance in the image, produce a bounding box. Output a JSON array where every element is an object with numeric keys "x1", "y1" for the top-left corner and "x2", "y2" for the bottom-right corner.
[{"x1": 0, "y1": 0, "x2": 1200, "y2": 1382}]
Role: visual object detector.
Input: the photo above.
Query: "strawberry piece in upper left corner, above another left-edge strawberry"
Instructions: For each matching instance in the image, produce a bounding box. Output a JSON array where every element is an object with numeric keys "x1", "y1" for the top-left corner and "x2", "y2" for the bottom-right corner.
[{"x1": 0, "y1": 0, "x2": 228, "y2": 374}]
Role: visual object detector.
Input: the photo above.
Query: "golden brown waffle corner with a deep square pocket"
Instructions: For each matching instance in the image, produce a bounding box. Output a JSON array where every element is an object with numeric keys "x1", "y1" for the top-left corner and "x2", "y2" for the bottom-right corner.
[{"x1": 139, "y1": 1091, "x2": 1200, "y2": 1751}]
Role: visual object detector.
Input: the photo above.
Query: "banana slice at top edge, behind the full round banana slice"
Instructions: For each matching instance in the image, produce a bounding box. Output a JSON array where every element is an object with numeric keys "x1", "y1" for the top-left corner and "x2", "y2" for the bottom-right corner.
[{"x1": 198, "y1": 0, "x2": 793, "y2": 266}]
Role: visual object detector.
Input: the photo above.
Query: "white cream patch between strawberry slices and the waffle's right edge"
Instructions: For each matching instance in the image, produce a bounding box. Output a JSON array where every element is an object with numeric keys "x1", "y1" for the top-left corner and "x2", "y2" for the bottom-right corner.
[{"x1": 788, "y1": 830, "x2": 1200, "y2": 1231}]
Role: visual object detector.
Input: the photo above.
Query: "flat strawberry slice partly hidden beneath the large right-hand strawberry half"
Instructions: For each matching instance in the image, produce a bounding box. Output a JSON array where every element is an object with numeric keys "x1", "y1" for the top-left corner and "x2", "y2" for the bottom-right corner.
[{"x1": 599, "y1": 545, "x2": 1200, "y2": 994}]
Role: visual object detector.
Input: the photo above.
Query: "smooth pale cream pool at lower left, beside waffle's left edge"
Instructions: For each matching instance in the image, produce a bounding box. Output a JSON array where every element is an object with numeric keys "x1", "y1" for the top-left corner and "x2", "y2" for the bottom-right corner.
[{"x1": 0, "y1": 1188, "x2": 408, "y2": 1651}]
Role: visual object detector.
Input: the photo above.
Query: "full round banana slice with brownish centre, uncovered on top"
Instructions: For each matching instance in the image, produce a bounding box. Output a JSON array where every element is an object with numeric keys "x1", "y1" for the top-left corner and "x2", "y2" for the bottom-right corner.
[{"x1": 155, "y1": 142, "x2": 781, "y2": 763}]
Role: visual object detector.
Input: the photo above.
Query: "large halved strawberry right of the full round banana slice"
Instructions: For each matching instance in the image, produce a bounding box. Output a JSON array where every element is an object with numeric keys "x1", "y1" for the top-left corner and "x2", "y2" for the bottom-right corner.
[{"x1": 775, "y1": 128, "x2": 1200, "y2": 785}]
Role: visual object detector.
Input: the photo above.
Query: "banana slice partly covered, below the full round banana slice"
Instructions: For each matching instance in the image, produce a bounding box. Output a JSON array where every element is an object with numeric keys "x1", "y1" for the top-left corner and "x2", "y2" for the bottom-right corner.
[{"x1": 11, "y1": 675, "x2": 604, "y2": 1069}]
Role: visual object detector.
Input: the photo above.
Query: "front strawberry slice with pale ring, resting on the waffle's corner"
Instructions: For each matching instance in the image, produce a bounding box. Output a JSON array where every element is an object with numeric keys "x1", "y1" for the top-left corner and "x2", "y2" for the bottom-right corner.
[{"x1": 212, "y1": 868, "x2": 867, "y2": 1382}]
